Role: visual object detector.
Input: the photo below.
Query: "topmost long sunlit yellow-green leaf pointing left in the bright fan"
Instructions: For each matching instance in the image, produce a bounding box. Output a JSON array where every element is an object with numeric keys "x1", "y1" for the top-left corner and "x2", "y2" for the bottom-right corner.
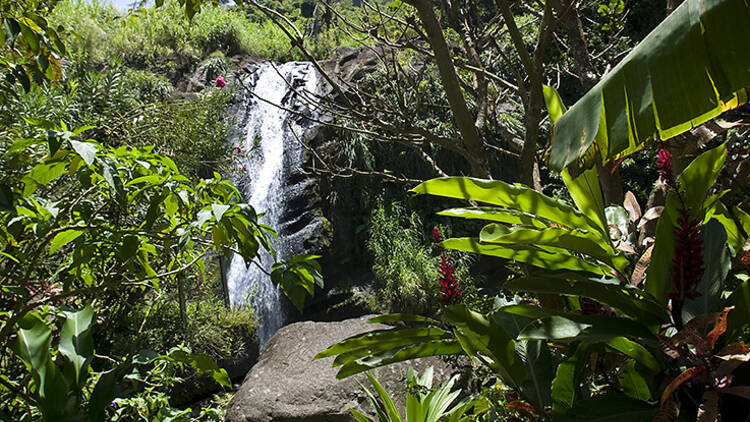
[{"x1": 412, "y1": 177, "x2": 601, "y2": 231}]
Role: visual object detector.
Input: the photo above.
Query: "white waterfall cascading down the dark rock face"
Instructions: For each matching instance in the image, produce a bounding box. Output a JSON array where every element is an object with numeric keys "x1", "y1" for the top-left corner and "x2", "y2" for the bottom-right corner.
[{"x1": 227, "y1": 62, "x2": 321, "y2": 349}]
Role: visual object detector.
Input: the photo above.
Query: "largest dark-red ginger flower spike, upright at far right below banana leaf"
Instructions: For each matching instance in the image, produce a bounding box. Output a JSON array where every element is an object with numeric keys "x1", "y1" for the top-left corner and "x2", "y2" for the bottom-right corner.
[{"x1": 670, "y1": 210, "x2": 704, "y2": 300}]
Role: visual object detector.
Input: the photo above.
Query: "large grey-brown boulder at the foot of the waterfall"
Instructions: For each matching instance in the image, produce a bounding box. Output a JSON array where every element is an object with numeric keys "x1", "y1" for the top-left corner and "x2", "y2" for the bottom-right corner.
[{"x1": 226, "y1": 316, "x2": 452, "y2": 422}]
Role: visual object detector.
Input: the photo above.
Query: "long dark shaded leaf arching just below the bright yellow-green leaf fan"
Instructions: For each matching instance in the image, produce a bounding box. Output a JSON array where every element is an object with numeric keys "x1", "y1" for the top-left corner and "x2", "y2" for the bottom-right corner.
[{"x1": 503, "y1": 277, "x2": 668, "y2": 324}]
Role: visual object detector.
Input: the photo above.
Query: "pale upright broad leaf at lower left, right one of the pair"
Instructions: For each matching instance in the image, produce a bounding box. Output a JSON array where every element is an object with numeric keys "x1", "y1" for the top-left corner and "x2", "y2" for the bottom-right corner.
[{"x1": 59, "y1": 306, "x2": 94, "y2": 388}]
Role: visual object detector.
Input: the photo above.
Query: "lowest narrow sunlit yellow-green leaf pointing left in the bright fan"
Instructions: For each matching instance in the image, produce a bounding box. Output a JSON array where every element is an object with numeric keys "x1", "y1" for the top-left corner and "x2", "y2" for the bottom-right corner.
[{"x1": 441, "y1": 237, "x2": 607, "y2": 275}]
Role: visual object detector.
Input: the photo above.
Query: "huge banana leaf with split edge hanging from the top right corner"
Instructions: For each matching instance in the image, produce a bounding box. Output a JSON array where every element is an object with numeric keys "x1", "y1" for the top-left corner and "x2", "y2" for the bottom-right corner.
[{"x1": 549, "y1": 0, "x2": 750, "y2": 171}]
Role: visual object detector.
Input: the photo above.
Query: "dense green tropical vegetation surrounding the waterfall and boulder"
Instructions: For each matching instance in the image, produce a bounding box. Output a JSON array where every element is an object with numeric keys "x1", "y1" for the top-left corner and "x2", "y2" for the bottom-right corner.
[{"x1": 0, "y1": 0, "x2": 750, "y2": 422}]
